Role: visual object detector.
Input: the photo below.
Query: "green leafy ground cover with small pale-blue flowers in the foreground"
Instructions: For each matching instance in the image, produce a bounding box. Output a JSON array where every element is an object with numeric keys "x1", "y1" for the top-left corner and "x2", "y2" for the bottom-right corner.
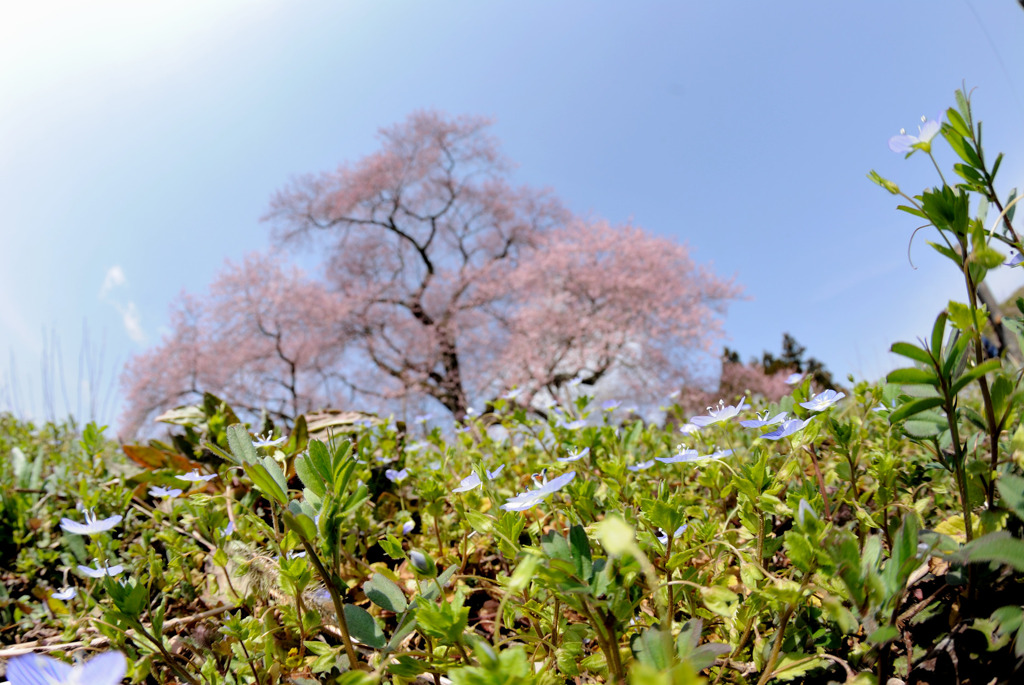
[{"x1": 6, "y1": 92, "x2": 1024, "y2": 685}]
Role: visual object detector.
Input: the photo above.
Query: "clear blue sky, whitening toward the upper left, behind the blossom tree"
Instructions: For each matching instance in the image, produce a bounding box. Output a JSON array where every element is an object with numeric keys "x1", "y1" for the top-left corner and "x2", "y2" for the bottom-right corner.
[{"x1": 0, "y1": 0, "x2": 1024, "y2": 421}]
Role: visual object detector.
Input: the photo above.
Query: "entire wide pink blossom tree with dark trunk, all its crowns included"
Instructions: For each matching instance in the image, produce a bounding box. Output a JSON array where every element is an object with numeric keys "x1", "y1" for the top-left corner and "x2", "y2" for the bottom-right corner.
[{"x1": 126, "y1": 112, "x2": 739, "y2": 432}]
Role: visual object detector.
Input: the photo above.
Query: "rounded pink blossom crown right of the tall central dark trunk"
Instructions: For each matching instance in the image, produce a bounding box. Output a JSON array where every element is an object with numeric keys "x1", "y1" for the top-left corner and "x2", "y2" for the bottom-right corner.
[{"x1": 479, "y1": 218, "x2": 739, "y2": 402}]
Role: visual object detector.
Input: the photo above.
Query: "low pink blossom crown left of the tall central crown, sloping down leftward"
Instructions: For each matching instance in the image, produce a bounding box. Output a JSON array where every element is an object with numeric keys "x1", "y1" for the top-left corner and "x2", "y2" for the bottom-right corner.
[{"x1": 121, "y1": 255, "x2": 347, "y2": 435}]
